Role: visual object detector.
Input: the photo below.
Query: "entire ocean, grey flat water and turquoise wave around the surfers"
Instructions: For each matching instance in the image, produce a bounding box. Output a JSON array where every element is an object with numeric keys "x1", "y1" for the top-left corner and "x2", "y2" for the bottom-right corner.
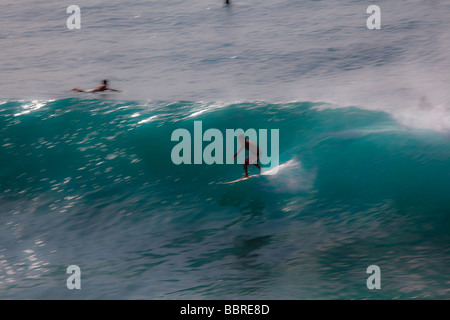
[{"x1": 0, "y1": 0, "x2": 450, "y2": 299}]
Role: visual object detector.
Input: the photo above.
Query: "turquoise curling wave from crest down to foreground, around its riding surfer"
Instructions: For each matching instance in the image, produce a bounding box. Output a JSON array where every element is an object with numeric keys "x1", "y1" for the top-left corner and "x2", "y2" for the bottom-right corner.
[{"x1": 0, "y1": 99, "x2": 450, "y2": 299}]
